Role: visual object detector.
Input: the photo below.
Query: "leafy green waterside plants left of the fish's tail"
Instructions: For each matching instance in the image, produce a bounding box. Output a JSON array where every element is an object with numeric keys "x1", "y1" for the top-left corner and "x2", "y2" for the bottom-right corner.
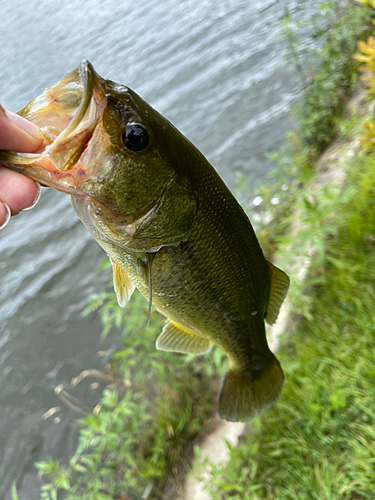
[{"x1": 36, "y1": 291, "x2": 226, "y2": 500}]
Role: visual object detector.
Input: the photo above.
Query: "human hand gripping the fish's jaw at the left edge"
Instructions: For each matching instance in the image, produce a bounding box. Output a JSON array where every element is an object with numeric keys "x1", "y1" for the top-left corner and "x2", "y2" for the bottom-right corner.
[{"x1": 0, "y1": 105, "x2": 43, "y2": 230}]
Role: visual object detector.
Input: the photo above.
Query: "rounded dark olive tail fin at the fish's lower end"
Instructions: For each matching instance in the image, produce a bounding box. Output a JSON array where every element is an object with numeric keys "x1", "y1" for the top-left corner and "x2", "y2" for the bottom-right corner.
[{"x1": 219, "y1": 356, "x2": 284, "y2": 422}]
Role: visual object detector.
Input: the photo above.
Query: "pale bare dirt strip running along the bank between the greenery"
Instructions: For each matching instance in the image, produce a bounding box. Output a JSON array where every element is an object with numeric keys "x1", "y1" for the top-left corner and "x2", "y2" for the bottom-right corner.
[{"x1": 183, "y1": 82, "x2": 375, "y2": 500}]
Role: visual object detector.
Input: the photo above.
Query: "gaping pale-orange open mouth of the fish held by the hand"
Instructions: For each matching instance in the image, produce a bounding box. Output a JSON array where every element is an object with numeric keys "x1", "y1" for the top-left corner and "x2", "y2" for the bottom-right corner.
[{"x1": 0, "y1": 61, "x2": 106, "y2": 196}]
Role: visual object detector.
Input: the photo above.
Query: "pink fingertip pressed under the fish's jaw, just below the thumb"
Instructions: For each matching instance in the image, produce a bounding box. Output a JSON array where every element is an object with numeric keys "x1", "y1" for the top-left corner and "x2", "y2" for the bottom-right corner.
[{"x1": 0, "y1": 166, "x2": 40, "y2": 215}]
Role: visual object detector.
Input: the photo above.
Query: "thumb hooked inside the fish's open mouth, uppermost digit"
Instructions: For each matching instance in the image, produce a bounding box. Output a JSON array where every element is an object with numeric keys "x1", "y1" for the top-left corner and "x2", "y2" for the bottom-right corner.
[{"x1": 0, "y1": 105, "x2": 43, "y2": 153}]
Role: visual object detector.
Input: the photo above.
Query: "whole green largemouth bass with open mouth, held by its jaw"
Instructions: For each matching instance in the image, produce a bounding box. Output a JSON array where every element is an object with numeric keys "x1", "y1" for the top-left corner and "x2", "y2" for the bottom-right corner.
[{"x1": 0, "y1": 61, "x2": 289, "y2": 422}]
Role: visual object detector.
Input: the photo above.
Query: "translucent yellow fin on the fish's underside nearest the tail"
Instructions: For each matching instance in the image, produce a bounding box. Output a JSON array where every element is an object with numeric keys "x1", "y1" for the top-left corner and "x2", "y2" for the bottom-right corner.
[{"x1": 156, "y1": 321, "x2": 211, "y2": 354}]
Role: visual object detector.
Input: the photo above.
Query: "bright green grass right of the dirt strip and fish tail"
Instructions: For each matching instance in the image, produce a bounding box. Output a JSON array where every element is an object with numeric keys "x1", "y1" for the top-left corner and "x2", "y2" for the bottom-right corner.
[{"x1": 201, "y1": 157, "x2": 375, "y2": 500}]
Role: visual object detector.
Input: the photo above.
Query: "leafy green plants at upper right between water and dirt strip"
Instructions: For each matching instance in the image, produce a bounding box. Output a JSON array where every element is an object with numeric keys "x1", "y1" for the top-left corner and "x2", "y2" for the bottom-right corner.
[{"x1": 237, "y1": 0, "x2": 375, "y2": 257}]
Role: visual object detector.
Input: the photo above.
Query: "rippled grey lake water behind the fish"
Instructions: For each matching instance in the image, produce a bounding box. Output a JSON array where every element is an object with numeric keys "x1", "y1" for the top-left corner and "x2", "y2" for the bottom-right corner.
[{"x1": 0, "y1": 0, "x2": 318, "y2": 500}]
